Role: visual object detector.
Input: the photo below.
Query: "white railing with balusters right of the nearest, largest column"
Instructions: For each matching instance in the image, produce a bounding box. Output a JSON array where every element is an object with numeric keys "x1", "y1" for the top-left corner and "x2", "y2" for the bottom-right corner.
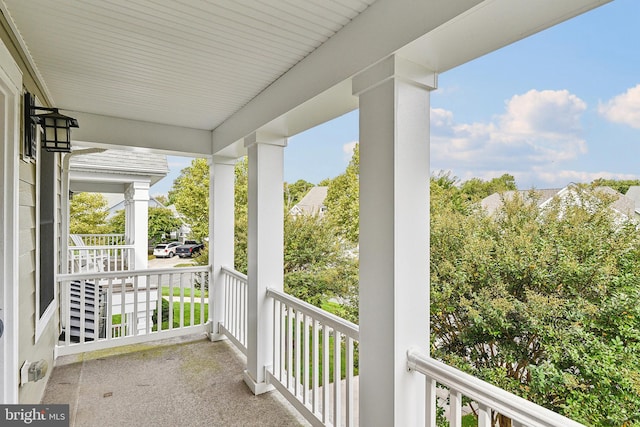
[{"x1": 407, "y1": 349, "x2": 584, "y2": 427}]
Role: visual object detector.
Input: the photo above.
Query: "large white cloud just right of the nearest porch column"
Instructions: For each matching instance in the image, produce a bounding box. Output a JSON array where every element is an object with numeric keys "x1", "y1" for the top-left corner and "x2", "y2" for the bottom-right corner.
[{"x1": 431, "y1": 90, "x2": 587, "y2": 178}]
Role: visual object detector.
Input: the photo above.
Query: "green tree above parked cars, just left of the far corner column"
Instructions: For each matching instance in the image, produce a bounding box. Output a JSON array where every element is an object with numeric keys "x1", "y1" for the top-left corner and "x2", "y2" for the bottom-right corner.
[{"x1": 169, "y1": 159, "x2": 209, "y2": 241}]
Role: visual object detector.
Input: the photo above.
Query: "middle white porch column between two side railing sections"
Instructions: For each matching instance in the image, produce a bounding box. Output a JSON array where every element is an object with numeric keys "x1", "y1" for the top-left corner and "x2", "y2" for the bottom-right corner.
[{"x1": 244, "y1": 134, "x2": 287, "y2": 394}]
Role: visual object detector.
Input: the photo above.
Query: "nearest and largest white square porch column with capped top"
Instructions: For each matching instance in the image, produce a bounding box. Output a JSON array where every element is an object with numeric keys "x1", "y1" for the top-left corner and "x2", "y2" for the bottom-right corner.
[{"x1": 353, "y1": 56, "x2": 436, "y2": 427}]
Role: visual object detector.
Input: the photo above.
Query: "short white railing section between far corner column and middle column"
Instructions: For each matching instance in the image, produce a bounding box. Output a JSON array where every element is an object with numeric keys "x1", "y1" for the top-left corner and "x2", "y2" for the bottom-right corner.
[{"x1": 219, "y1": 267, "x2": 247, "y2": 355}]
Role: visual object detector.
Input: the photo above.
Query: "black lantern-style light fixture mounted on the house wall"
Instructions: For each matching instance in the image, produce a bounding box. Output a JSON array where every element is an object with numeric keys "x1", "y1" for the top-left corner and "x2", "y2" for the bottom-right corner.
[{"x1": 24, "y1": 92, "x2": 78, "y2": 156}]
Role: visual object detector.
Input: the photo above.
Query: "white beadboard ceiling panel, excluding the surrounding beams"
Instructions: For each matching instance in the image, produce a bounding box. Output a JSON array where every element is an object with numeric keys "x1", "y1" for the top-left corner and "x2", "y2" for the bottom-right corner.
[{"x1": 4, "y1": 0, "x2": 375, "y2": 130}]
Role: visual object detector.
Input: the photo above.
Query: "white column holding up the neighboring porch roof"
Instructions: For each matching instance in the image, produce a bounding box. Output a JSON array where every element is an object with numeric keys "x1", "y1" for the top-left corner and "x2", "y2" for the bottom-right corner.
[{"x1": 125, "y1": 181, "x2": 149, "y2": 270}]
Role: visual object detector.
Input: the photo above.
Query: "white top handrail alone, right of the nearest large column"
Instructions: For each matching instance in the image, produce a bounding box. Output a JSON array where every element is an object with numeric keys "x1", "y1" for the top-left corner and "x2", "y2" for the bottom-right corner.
[{"x1": 407, "y1": 348, "x2": 584, "y2": 427}]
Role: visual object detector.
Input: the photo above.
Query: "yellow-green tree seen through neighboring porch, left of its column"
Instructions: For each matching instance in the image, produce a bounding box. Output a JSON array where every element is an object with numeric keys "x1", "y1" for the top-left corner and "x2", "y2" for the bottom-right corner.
[{"x1": 69, "y1": 193, "x2": 109, "y2": 234}]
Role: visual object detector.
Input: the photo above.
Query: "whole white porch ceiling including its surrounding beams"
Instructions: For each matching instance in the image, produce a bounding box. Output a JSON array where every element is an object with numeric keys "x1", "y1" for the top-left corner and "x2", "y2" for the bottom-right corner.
[{"x1": 0, "y1": 0, "x2": 609, "y2": 157}]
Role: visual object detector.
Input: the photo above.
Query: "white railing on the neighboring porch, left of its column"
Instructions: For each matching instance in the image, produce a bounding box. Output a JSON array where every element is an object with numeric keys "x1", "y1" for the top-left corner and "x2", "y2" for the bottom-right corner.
[{"x1": 69, "y1": 245, "x2": 135, "y2": 274}]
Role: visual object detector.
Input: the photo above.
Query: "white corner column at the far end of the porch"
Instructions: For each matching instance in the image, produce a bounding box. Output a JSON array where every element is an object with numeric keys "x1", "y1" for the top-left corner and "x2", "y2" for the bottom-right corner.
[{"x1": 209, "y1": 156, "x2": 236, "y2": 341}]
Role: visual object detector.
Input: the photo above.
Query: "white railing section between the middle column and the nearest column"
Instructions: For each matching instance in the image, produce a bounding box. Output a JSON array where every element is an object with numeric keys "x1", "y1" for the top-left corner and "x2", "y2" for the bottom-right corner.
[{"x1": 267, "y1": 289, "x2": 359, "y2": 426}]
